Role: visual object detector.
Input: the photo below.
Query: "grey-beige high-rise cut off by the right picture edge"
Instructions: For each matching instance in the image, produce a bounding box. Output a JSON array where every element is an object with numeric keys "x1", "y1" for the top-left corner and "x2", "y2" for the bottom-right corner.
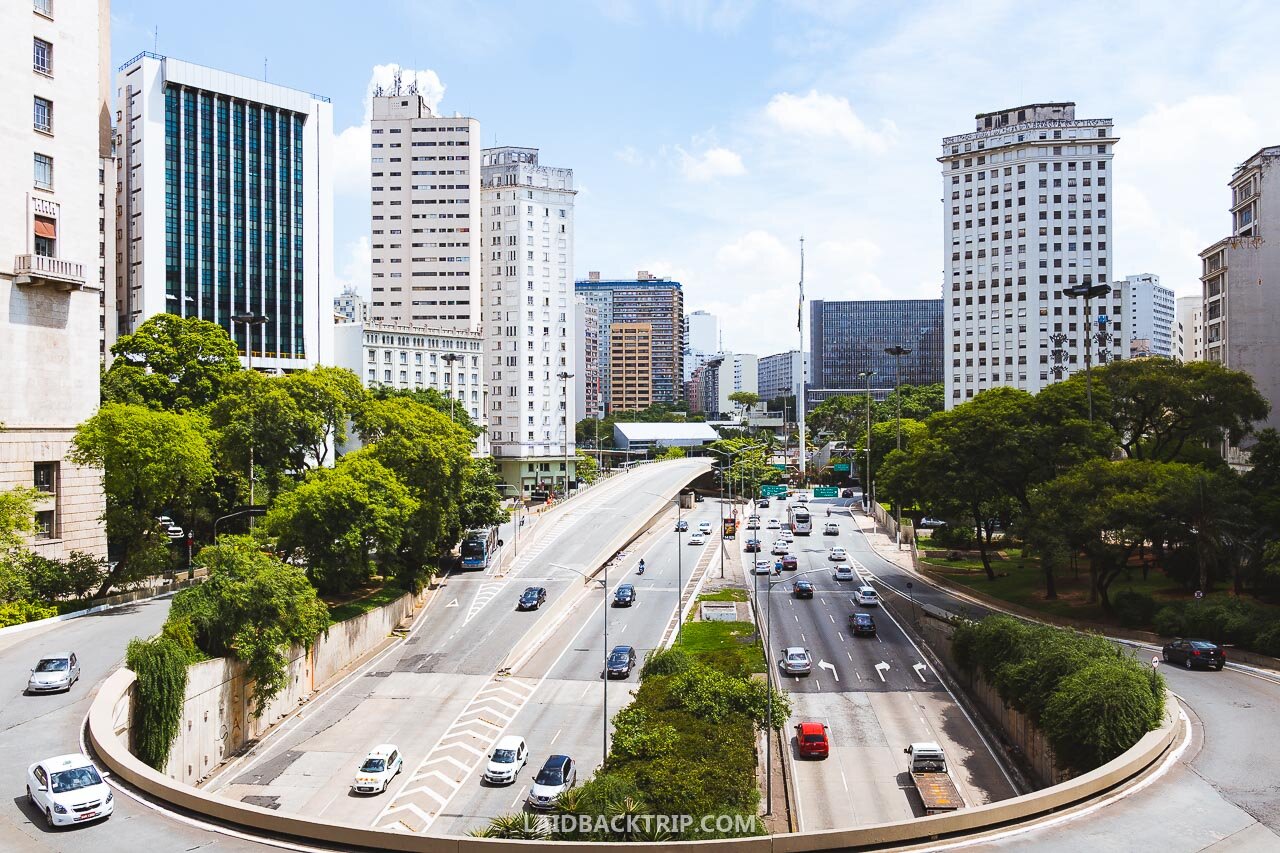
[{"x1": 1199, "y1": 146, "x2": 1280, "y2": 461}]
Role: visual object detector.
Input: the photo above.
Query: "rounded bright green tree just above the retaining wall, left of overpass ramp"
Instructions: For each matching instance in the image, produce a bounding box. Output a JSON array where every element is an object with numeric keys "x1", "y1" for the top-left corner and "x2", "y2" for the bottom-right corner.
[{"x1": 262, "y1": 451, "x2": 417, "y2": 593}]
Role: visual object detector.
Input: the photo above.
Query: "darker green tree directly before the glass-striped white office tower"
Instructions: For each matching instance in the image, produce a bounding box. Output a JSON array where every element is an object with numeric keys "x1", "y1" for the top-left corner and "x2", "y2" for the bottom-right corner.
[{"x1": 102, "y1": 314, "x2": 241, "y2": 411}]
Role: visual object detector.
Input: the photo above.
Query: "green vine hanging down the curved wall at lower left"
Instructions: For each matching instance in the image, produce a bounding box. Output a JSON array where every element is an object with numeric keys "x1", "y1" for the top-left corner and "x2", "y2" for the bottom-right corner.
[{"x1": 124, "y1": 637, "x2": 189, "y2": 772}]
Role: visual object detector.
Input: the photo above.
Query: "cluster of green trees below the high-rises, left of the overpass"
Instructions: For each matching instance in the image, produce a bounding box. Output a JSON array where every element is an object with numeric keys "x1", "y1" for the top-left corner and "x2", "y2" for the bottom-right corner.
[{"x1": 72, "y1": 314, "x2": 504, "y2": 596}]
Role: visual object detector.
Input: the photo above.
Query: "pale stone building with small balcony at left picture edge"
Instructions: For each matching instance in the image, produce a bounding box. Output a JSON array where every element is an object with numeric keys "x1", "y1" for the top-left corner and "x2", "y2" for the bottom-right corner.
[{"x1": 0, "y1": 0, "x2": 115, "y2": 558}]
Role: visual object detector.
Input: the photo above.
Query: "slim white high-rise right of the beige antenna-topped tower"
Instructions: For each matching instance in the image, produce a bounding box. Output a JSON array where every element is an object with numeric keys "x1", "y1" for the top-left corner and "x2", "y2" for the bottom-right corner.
[{"x1": 480, "y1": 147, "x2": 579, "y2": 493}]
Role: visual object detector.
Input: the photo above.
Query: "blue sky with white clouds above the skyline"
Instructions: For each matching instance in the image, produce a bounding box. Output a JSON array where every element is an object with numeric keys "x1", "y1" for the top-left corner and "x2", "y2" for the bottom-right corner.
[{"x1": 111, "y1": 0, "x2": 1280, "y2": 356}]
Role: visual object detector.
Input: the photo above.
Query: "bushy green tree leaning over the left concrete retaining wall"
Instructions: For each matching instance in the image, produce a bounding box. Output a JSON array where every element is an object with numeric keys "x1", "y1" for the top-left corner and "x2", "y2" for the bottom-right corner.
[{"x1": 165, "y1": 537, "x2": 329, "y2": 716}]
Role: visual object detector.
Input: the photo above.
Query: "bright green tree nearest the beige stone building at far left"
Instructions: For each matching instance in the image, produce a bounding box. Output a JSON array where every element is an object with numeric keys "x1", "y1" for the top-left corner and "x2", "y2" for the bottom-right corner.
[{"x1": 69, "y1": 403, "x2": 214, "y2": 598}]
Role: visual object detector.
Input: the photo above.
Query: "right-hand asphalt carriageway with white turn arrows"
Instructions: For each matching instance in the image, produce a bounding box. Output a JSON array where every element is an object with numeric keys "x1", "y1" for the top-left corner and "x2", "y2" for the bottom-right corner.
[{"x1": 755, "y1": 500, "x2": 1016, "y2": 830}]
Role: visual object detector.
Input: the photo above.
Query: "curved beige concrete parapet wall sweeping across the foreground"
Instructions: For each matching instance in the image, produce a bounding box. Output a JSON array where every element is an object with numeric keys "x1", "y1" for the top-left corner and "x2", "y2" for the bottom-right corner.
[{"x1": 88, "y1": 669, "x2": 1181, "y2": 853}]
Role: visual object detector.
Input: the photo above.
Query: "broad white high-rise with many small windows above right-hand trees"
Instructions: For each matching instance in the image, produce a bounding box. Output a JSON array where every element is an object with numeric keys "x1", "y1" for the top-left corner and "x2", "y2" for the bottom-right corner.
[{"x1": 942, "y1": 102, "x2": 1128, "y2": 407}]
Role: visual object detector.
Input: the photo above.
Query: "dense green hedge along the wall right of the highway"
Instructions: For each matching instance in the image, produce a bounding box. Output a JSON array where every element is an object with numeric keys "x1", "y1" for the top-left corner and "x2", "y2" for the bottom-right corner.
[{"x1": 952, "y1": 616, "x2": 1165, "y2": 772}]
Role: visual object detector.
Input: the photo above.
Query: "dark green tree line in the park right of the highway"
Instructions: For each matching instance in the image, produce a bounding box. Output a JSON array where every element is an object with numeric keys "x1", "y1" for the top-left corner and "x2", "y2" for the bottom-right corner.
[{"x1": 877, "y1": 359, "x2": 1280, "y2": 625}]
